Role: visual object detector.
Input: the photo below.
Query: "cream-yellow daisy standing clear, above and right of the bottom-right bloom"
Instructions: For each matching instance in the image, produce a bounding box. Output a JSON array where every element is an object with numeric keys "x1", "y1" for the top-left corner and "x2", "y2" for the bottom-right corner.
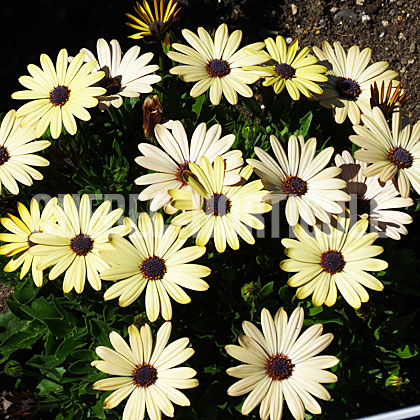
[{"x1": 280, "y1": 212, "x2": 388, "y2": 309}]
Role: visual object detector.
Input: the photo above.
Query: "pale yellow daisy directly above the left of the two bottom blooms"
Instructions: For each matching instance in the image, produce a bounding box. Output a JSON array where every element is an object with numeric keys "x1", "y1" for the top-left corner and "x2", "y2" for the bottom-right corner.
[{"x1": 101, "y1": 213, "x2": 211, "y2": 322}]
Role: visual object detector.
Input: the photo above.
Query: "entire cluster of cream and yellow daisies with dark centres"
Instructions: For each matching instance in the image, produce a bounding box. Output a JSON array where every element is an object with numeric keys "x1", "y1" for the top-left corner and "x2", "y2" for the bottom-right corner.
[{"x1": 0, "y1": 0, "x2": 420, "y2": 420}]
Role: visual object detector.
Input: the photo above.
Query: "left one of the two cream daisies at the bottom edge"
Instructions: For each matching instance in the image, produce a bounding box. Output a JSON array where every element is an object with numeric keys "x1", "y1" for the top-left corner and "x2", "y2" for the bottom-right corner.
[{"x1": 92, "y1": 322, "x2": 198, "y2": 420}]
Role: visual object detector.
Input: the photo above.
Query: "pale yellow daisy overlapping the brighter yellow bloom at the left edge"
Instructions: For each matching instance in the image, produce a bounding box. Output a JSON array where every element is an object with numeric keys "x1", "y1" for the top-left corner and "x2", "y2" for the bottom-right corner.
[{"x1": 29, "y1": 194, "x2": 130, "y2": 293}]
